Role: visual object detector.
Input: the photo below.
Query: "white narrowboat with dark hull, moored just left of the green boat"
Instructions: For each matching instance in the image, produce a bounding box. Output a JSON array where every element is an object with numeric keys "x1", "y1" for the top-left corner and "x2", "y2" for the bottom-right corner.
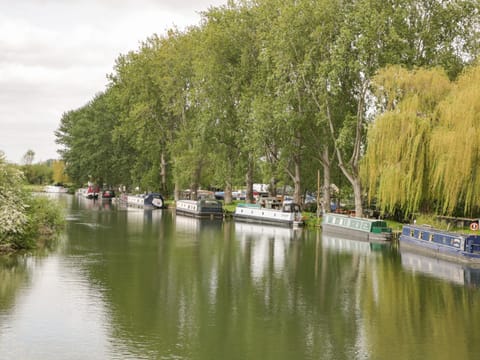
[{"x1": 233, "y1": 203, "x2": 304, "y2": 226}]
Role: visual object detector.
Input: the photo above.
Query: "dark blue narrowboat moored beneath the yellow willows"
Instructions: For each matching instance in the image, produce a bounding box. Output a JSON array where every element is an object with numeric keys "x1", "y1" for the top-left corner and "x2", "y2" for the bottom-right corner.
[{"x1": 400, "y1": 225, "x2": 480, "y2": 263}]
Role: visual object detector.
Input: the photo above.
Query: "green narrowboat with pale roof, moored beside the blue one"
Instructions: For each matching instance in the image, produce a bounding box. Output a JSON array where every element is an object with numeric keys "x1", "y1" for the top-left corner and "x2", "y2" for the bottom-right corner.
[{"x1": 322, "y1": 213, "x2": 392, "y2": 241}]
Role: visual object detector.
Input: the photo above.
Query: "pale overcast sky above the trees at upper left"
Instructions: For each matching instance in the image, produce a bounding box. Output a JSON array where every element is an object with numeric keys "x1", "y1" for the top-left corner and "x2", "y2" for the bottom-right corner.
[{"x1": 0, "y1": 0, "x2": 227, "y2": 163}]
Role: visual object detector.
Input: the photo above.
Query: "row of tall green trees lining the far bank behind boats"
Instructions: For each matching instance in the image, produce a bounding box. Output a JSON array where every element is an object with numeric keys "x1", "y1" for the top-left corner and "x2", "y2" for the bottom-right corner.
[{"x1": 56, "y1": 0, "x2": 479, "y2": 215}]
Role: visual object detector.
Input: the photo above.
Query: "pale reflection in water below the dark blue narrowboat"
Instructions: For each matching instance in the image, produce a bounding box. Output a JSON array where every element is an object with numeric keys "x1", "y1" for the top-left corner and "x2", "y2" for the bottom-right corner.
[{"x1": 400, "y1": 248, "x2": 480, "y2": 288}]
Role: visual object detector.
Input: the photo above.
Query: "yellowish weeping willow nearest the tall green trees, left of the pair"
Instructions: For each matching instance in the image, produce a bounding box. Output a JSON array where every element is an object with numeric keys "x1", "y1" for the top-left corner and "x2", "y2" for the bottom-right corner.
[{"x1": 361, "y1": 66, "x2": 452, "y2": 214}]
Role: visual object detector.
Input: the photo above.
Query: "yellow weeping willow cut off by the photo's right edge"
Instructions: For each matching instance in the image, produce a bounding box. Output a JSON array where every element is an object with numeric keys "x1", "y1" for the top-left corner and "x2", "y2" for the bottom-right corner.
[{"x1": 430, "y1": 64, "x2": 480, "y2": 215}]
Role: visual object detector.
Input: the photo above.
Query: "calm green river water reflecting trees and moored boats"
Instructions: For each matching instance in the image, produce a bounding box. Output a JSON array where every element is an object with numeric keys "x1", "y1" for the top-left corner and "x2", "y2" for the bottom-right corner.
[{"x1": 0, "y1": 195, "x2": 480, "y2": 360}]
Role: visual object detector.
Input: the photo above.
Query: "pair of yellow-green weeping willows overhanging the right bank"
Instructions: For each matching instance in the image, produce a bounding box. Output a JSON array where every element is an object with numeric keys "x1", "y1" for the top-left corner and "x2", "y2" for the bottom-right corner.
[{"x1": 363, "y1": 66, "x2": 480, "y2": 215}]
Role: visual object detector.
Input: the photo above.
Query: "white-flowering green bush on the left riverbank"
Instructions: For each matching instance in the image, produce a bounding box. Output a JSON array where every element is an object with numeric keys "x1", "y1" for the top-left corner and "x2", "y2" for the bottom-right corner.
[{"x1": 0, "y1": 153, "x2": 65, "y2": 253}]
